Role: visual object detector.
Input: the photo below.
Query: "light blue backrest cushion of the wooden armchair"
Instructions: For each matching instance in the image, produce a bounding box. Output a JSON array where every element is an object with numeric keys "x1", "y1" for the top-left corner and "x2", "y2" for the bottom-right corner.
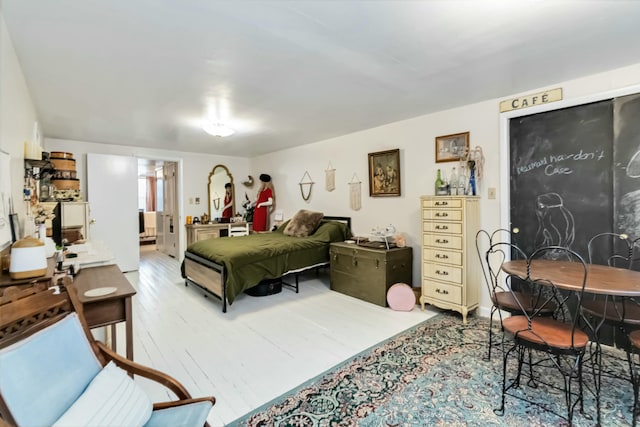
[{"x1": 0, "y1": 313, "x2": 102, "y2": 426}]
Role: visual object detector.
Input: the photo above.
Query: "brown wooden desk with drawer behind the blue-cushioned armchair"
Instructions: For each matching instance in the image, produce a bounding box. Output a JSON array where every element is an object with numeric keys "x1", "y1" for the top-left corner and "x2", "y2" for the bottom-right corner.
[{"x1": 73, "y1": 264, "x2": 136, "y2": 360}]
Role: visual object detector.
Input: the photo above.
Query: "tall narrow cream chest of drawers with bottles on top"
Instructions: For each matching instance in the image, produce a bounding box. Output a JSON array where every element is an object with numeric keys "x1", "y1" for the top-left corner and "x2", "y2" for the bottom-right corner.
[{"x1": 420, "y1": 196, "x2": 482, "y2": 323}]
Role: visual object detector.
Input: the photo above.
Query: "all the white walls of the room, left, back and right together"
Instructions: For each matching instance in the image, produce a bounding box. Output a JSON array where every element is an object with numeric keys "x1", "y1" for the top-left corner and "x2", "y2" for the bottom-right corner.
[{"x1": 6, "y1": 2, "x2": 640, "y2": 318}]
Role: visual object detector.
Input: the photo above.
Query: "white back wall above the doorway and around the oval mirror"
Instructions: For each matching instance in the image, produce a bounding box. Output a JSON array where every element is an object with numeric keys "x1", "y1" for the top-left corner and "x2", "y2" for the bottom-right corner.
[{"x1": 44, "y1": 138, "x2": 250, "y2": 257}]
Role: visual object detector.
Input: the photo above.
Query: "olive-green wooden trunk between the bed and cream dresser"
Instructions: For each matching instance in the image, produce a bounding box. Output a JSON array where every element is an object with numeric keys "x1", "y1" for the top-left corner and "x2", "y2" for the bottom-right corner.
[{"x1": 330, "y1": 243, "x2": 413, "y2": 307}]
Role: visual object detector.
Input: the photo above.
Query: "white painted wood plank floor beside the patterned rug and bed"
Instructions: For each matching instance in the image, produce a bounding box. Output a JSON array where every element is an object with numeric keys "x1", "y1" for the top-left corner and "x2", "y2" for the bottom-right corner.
[{"x1": 117, "y1": 245, "x2": 436, "y2": 427}]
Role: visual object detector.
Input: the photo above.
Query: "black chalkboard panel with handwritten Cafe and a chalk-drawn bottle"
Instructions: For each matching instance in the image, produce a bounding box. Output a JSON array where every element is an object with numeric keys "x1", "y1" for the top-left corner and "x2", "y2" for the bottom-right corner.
[{"x1": 509, "y1": 100, "x2": 626, "y2": 259}]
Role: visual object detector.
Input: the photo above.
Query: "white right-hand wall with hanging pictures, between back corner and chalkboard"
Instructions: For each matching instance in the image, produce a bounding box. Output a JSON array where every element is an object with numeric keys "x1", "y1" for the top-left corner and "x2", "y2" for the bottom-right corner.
[{"x1": 251, "y1": 64, "x2": 640, "y2": 313}]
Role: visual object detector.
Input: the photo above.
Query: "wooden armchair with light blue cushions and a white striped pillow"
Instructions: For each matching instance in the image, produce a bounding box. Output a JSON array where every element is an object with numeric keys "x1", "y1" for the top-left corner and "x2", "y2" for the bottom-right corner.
[{"x1": 0, "y1": 283, "x2": 215, "y2": 427}]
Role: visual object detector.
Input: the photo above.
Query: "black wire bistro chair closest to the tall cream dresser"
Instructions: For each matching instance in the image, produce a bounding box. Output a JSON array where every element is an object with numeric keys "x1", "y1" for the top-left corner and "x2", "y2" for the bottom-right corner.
[{"x1": 476, "y1": 228, "x2": 555, "y2": 360}]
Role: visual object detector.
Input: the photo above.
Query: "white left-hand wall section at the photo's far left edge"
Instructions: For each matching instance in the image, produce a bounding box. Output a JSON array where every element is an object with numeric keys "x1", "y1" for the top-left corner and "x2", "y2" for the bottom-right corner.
[{"x1": 0, "y1": 12, "x2": 37, "y2": 227}]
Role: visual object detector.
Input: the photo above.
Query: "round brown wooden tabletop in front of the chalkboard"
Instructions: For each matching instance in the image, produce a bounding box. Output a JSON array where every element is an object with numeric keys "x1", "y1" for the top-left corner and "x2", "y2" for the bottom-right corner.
[{"x1": 502, "y1": 260, "x2": 640, "y2": 297}]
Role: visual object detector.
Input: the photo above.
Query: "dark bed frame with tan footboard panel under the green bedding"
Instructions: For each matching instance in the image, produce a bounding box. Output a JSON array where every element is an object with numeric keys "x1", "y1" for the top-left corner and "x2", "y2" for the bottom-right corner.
[{"x1": 183, "y1": 216, "x2": 351, "y2": 313}]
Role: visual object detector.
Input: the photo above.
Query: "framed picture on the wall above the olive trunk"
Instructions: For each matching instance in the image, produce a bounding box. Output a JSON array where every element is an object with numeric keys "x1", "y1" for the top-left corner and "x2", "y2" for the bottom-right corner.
[{"x1": 369, "y1": 148, "x2": 400, "y2": 197}]
